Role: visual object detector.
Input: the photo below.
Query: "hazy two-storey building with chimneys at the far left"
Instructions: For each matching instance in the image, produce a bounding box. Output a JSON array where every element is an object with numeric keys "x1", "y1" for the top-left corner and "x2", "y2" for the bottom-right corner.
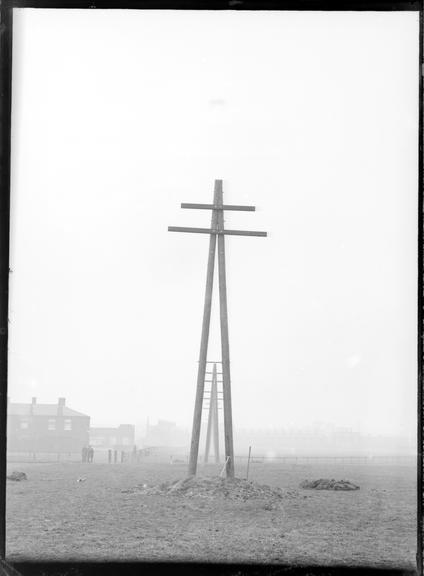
[{"x1": 7, "y1": 398, "x2": 90, "y2": 454}]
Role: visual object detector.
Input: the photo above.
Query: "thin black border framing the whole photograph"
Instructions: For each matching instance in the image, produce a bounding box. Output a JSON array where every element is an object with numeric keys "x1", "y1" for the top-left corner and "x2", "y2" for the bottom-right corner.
[{"x1": 0, "y1": 0, "x2": 424, "y2": 576}]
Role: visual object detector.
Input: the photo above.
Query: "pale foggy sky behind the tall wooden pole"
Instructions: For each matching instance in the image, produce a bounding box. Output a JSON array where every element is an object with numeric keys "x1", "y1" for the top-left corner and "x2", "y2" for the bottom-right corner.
[{"x1": 9, "y1": 9, "x2": 418, "y2": 434}]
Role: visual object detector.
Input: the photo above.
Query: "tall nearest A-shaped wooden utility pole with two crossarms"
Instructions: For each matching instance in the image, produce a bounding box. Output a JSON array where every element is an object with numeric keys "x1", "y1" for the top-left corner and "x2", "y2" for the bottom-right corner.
[{"x1": 168, "y1": 180, "x2": 267, "y2": 478}]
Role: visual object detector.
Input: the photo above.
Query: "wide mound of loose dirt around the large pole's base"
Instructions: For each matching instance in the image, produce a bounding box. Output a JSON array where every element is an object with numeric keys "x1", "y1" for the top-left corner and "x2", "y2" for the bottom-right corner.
[{"x1": 122, "y1": 476, "x2": 283, "y2": 505}]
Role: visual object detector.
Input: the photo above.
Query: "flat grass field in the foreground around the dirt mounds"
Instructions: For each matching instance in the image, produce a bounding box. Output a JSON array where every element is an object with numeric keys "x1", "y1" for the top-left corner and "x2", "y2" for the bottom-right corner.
[{"x1": 6, "y1": 461, "x2": 416, "y2": 569}]
